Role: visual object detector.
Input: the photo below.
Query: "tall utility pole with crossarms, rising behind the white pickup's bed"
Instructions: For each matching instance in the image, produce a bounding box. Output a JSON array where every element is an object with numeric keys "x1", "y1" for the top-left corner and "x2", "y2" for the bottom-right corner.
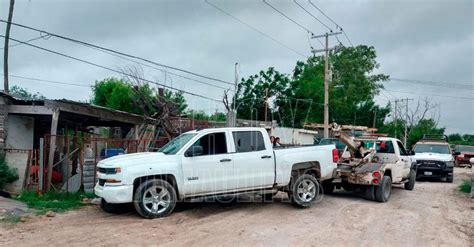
[{"x1": 311, "y1": 32, "x2": 341, "y2": 138}]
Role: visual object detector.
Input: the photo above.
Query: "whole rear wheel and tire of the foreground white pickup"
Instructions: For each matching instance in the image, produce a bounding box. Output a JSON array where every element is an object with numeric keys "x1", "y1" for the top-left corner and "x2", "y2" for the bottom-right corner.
[{"x1": 288, "y1": 174, "x2": 319, "y2": 208}]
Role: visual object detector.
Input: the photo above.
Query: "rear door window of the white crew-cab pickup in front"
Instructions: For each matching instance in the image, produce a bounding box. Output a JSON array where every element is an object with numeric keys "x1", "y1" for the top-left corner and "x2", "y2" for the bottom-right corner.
[{"x1": 232, "y1": 131, "x2": 265, "y2": 153}]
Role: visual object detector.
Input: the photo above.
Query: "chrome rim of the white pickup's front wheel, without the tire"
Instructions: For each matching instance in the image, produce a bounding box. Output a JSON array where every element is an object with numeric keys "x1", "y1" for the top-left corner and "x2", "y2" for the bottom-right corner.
[{"x1": 142, "y1": 185, "x2": 171, "y2": 214}]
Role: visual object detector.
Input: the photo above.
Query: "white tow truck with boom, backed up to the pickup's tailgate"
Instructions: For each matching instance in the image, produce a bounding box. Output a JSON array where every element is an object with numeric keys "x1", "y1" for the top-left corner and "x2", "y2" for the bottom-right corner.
[{"x1": 322, "y1": 123, "x2": 416, "y2": 202}]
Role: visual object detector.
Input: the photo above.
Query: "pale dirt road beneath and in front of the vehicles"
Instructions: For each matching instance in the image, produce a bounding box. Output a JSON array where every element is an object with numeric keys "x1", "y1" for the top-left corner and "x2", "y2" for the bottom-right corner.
[{"x1": 0, "y1": 168, "x2": 474, "y2": 246}]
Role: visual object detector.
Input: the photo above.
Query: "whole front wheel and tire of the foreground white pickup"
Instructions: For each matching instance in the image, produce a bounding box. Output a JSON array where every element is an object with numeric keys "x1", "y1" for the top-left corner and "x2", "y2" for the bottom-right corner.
[{"x1": 133, "y1": 179, "x2": 177, "y2": 219}]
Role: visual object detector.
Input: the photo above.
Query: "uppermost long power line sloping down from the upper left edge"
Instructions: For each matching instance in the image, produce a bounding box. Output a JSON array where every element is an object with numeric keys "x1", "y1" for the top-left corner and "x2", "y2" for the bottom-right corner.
[{"x1": 0, "y1": 19, "x2": 234, "y2": 86}]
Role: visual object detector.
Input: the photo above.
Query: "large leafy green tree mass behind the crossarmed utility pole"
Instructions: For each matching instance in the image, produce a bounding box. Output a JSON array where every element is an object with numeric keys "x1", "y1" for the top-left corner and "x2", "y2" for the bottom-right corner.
[{"x1": 237, "y1": 45, "x2": 390, "y2": 127}]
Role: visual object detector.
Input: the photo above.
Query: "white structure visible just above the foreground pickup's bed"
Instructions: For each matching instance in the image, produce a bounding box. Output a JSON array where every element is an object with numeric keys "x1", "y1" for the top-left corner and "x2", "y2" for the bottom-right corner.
[{"x1": 269, "y1": 127, "x2": 318, "y2": 145}]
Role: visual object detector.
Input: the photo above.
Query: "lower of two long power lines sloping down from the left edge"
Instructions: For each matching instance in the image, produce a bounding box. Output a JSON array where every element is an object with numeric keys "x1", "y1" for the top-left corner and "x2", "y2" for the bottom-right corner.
[{"x1": 0, "y1": 35, "x2": 221, "y2": 102}]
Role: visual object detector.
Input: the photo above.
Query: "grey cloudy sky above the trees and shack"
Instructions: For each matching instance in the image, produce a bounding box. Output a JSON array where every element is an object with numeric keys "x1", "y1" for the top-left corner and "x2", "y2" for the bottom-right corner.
[{"x1": 0, "y1": 0, "x2": 474, "y2": 134}]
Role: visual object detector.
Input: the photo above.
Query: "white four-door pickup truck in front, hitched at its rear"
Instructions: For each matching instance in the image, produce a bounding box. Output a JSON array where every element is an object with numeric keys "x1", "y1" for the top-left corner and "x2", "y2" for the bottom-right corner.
[{"x1": 95, "y1": 128, "x2": 338, "y2": 218}]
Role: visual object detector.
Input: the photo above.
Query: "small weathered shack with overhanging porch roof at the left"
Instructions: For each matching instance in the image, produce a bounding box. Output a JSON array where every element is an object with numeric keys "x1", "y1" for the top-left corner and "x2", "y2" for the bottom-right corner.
[{"x1": 0, "y1": 92, "x2": 153, "y2": 191}]
